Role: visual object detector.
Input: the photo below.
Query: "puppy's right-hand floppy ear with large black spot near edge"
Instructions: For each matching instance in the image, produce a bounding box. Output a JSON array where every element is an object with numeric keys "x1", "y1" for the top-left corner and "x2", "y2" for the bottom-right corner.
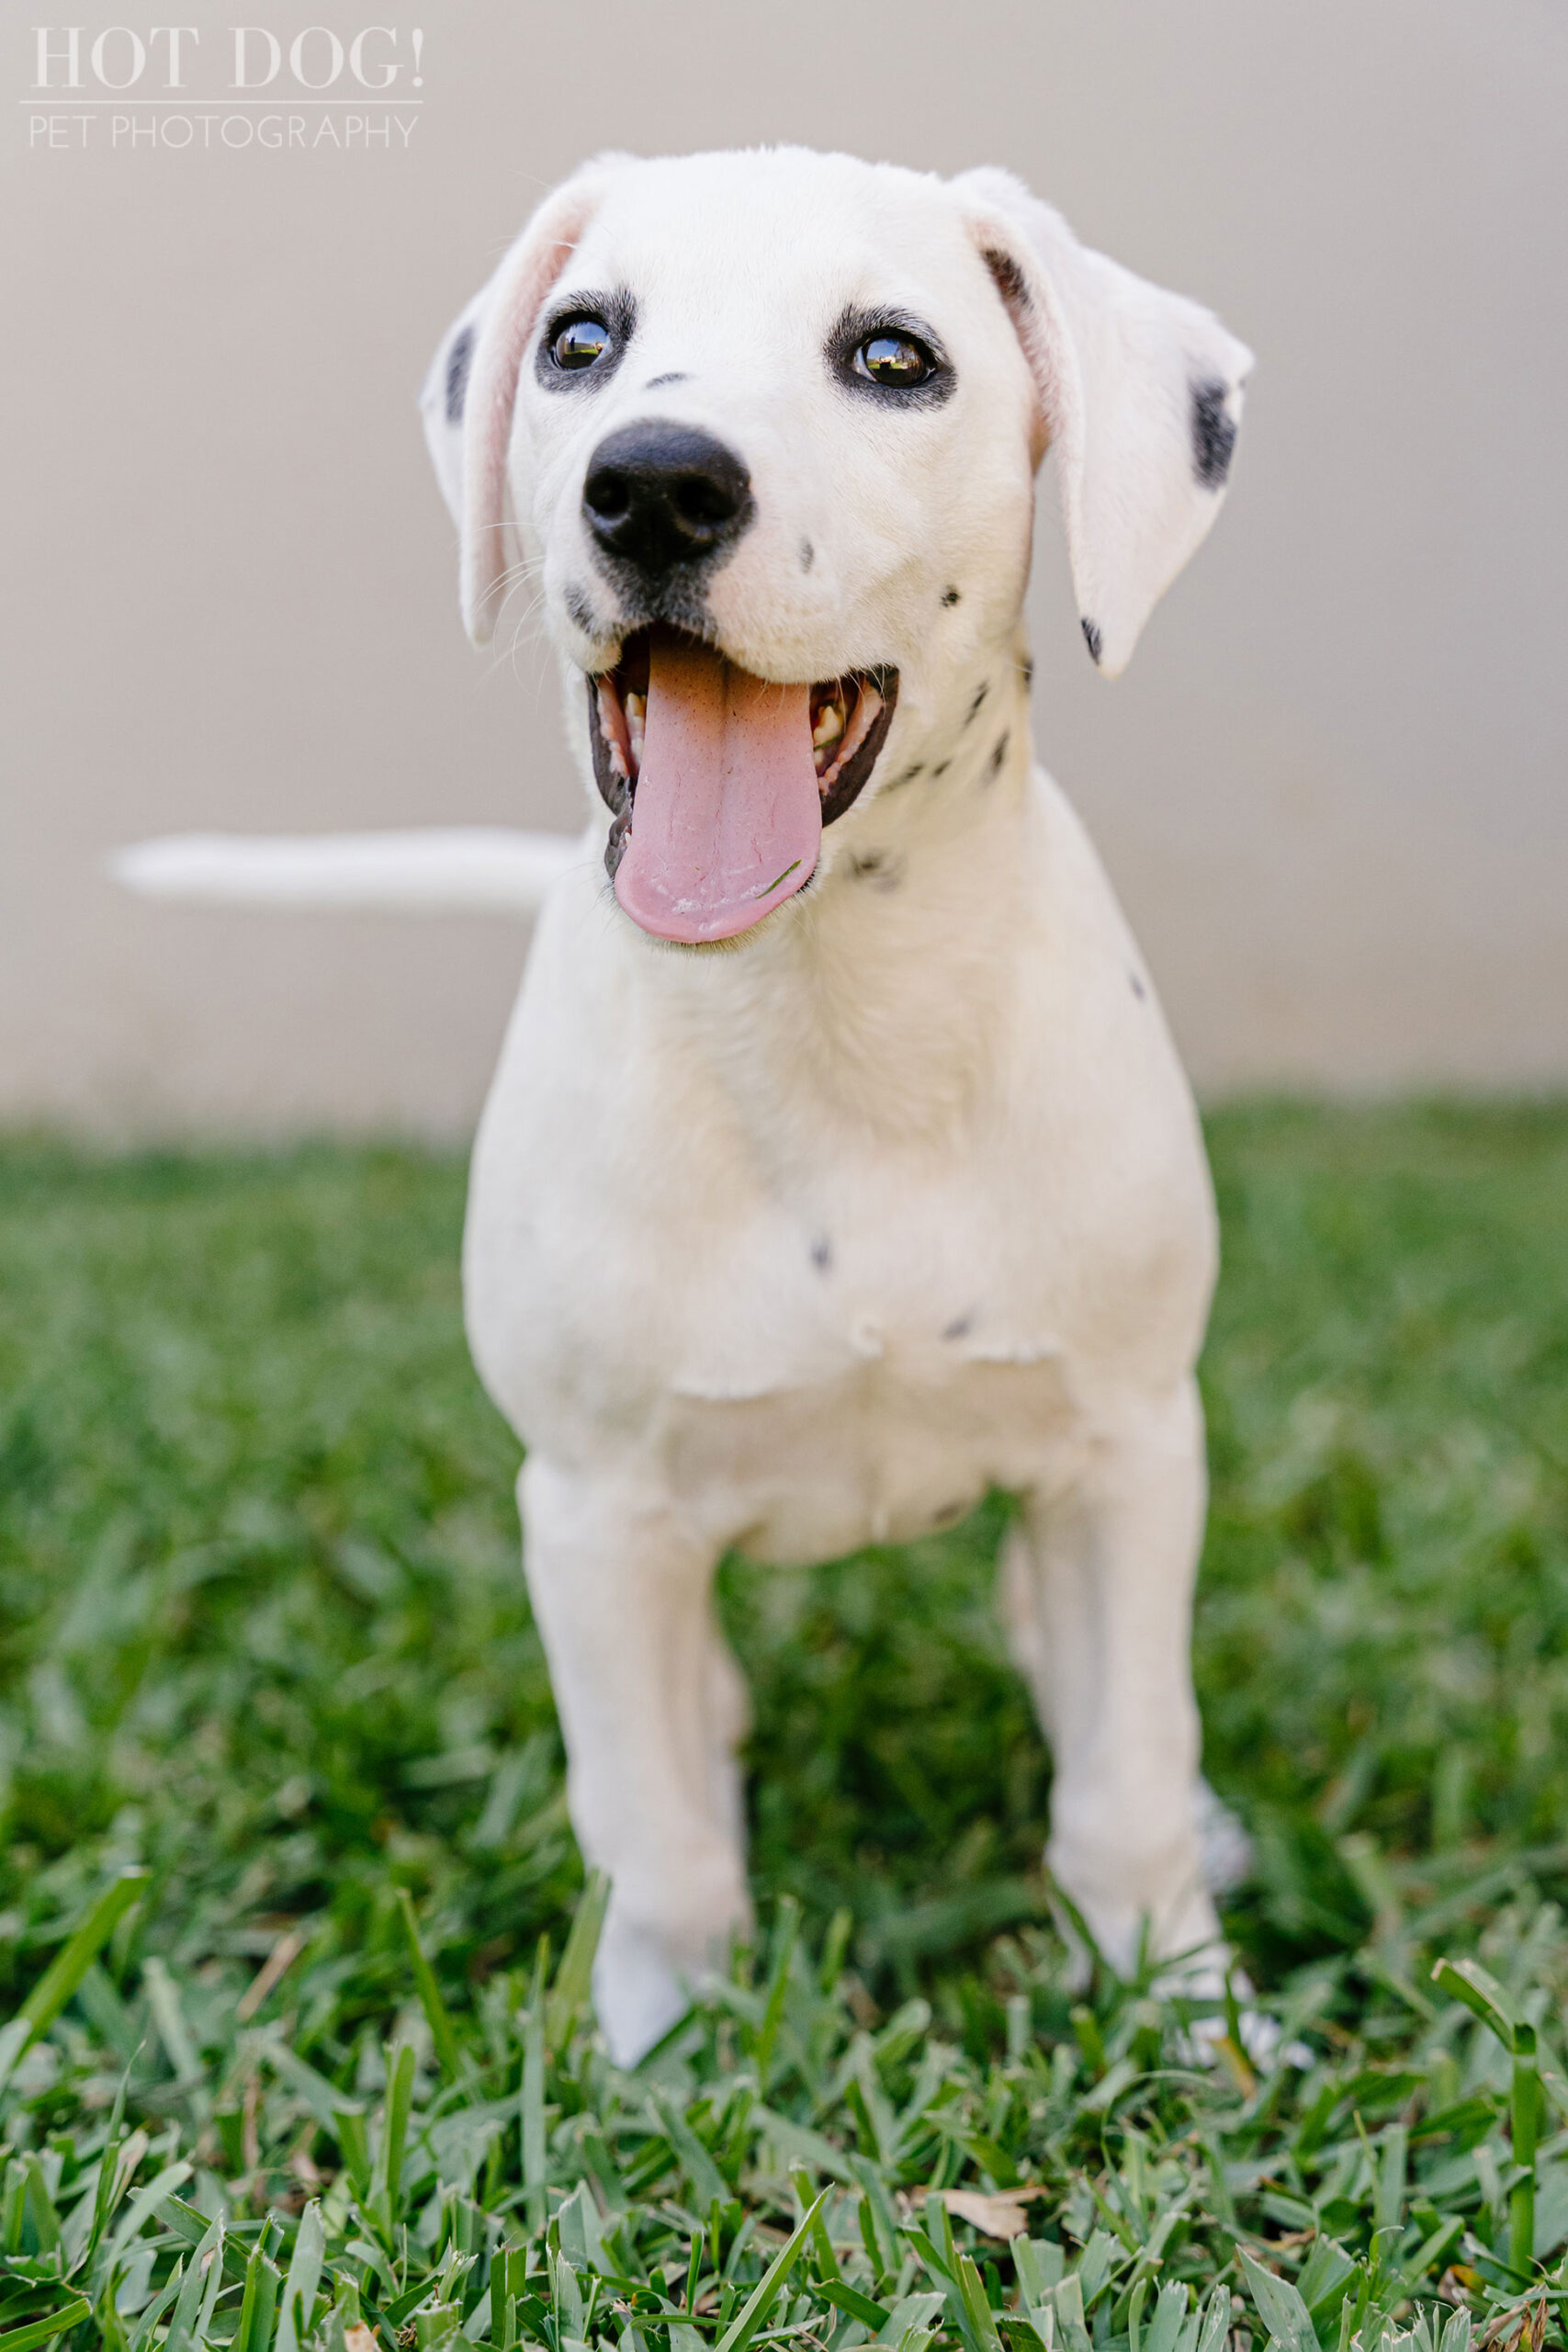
[{"x1": 954, "y1": 169, "x2": 1253, "y2": 677}]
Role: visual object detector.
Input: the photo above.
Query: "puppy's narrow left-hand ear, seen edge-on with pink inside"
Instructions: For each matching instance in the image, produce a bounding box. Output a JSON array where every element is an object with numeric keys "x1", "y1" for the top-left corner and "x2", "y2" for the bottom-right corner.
[{"x1": 419, "y1": 164, "x2": 606, "y2": 644}]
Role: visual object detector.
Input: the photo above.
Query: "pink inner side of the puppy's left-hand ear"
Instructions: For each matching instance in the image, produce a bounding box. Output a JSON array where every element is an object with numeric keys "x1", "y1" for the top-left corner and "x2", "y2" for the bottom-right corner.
[{"x1": 461, "y1": 172, "x2": 604, "y2": 644}]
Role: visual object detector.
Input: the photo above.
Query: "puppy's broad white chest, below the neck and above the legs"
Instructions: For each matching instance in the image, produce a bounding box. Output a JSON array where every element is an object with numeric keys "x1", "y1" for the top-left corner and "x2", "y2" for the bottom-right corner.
[{"x1": 466, "y1": 832, "x2": 1211, "y2": 1559}]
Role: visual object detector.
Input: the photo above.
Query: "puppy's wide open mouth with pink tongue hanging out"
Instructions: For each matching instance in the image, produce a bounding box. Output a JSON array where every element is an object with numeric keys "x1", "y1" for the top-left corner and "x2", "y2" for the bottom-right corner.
[{"x1": 588, "y1": 626, "x2": 898, "y2": 945}]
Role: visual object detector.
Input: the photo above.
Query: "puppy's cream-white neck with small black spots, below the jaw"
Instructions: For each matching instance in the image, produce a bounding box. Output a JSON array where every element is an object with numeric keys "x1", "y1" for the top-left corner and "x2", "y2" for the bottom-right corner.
[{"x1": 637, "y1": 651, "x2": 1032, "y2": 1158}]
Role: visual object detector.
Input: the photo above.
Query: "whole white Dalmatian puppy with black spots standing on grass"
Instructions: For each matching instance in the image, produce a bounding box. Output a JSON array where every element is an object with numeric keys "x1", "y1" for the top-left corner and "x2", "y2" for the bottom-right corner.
[{"x1": 122, "y1": 148, "x2": 1251, "y2": 2063}]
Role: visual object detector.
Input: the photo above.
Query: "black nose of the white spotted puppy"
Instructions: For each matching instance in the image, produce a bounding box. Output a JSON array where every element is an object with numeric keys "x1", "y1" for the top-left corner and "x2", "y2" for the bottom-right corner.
[{"x1": 583, "y1": 419, "x2": 755, "y2": 576}]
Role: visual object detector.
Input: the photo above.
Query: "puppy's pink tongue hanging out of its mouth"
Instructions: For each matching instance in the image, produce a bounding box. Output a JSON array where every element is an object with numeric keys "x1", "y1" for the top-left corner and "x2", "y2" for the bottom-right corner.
[{"x1": 616, "y1": 633, "x2": 823, "y2": 944}]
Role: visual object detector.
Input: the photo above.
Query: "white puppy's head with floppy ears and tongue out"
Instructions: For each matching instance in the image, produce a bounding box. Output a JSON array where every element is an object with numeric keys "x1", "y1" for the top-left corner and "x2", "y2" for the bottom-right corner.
[{"x1": 421, "y1": 148, "x2": 1251, "y2": 944}]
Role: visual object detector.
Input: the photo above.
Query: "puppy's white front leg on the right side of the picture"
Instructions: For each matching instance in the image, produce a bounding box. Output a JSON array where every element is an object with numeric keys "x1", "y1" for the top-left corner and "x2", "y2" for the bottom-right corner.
[{"x1": 1001, "y1": 1381, "x2": 1223, "y2": 1975}]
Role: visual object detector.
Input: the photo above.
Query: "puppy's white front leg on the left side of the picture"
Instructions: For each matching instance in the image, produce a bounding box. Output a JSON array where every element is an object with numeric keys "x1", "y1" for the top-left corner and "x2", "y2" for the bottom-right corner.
[{"x1": 517, "y1": 1456, "x2": 750, "y2": 2065}]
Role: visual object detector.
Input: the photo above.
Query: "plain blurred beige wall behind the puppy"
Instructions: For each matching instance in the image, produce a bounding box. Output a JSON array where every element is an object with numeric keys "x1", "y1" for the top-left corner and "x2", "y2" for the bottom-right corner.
[{"x1": 0, "y1": 0, "x2": 1568, "y2": 1131}]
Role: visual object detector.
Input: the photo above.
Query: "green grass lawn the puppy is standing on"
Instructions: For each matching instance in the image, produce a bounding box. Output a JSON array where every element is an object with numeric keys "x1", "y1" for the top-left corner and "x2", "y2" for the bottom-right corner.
[{"x1": 0, "y1": 1108, "x2": 1568, "y2": 2352}]
